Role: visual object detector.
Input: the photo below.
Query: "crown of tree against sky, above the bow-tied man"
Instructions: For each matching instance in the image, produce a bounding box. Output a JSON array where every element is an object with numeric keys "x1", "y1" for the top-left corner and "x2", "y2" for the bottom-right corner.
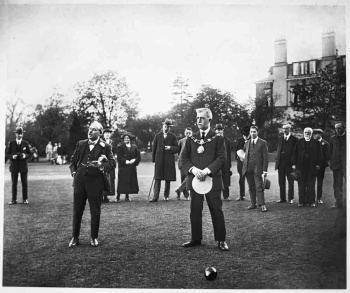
[{"x1": 72, "y1": 71, "x2": 139, "y2": 128}]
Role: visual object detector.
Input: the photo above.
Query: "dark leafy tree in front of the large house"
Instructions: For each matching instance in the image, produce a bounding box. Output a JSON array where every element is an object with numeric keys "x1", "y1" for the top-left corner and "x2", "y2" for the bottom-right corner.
[{"x1": 291, "y1": 64, "x2": 346, "y2": 132}]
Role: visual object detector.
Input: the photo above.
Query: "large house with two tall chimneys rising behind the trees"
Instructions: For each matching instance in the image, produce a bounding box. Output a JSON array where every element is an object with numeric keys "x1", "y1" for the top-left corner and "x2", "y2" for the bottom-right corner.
[{"x1": 256, "y1": 29, "x2": 346, "y2": 113}]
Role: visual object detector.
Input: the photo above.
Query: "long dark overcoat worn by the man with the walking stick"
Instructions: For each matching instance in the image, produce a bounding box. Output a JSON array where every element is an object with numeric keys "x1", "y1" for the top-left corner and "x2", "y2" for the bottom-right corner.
[{"x1": 152, "y1": 132, "x2": 179, "y2": 181}]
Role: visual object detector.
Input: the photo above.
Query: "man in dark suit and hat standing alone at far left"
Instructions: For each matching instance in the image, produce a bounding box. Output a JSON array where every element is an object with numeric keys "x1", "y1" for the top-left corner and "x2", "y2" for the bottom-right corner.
[{"x1": 6, "y1": 127, "x2": 31, "y2": 205}]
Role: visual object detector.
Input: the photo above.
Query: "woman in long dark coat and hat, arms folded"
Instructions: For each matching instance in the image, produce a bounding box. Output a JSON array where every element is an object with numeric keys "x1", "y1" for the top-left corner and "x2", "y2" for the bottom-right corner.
[{"x1": 117, "y1": 133, "x2": 141, "y2": 202}]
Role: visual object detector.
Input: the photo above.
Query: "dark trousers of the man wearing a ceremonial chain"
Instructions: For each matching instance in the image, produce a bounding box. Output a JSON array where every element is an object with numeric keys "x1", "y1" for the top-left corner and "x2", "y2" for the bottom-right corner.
[{"x1": 190, "y1": 190, "x2": 226, "y2": 241}]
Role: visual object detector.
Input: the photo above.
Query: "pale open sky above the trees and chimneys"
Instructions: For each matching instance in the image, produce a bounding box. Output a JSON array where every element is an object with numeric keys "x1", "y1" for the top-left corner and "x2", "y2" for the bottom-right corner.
[{"x1": 1, "y1": 1, "x2": 346, "y2": 116}]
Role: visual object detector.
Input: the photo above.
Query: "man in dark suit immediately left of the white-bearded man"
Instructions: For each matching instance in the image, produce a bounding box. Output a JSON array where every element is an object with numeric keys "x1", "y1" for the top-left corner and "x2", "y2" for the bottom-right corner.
[{"x1": 275, "y1": 124, "x2": 298, "y2": 203}]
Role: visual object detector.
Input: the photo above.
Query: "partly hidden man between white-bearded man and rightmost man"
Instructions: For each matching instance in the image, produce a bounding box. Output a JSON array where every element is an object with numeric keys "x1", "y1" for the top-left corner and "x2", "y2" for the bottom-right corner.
[{"x1": 313, "y1": 129, "x2": 329, "y2": 204}]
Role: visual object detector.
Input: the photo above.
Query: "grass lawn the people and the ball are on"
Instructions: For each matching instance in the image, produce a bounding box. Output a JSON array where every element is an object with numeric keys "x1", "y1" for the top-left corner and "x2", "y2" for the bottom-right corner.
[{"x1": 3, "y1": 162, "x2": 346, "y2": 289}]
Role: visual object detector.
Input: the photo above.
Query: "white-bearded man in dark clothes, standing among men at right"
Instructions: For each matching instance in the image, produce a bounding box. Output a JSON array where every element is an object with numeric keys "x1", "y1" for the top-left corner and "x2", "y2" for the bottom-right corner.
[{"x1": 292, "y1": 127, "x2": 322, "y2": 207}]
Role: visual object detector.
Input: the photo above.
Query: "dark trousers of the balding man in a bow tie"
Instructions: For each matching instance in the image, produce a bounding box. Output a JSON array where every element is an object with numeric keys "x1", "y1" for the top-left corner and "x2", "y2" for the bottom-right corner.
[{"x1": 73, "y1": 170, "x2": 103, "y2": 238}]
